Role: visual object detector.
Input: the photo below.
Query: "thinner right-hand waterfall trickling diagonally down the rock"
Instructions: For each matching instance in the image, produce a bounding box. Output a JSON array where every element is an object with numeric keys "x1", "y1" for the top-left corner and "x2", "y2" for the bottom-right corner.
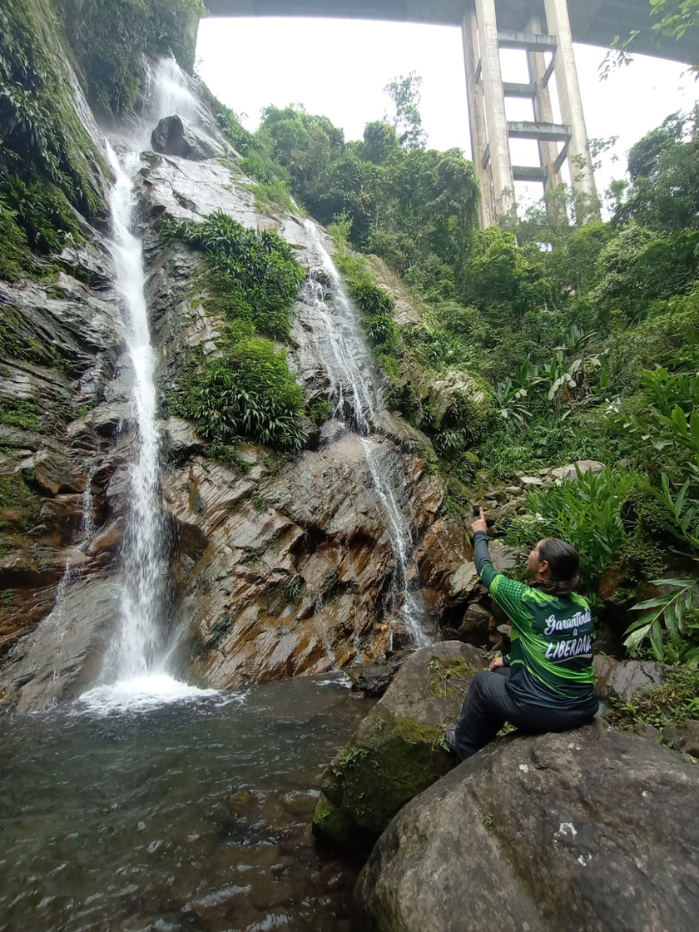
[{"x1": 305, "y1": 220, "x2": 430, "y2": 647}]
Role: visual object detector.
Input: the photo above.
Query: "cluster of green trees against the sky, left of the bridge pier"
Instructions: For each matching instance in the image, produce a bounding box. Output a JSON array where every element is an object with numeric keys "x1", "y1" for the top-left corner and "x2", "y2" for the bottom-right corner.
[{"x1": 235, "y1": 75, "x2": 478, "y2": 297}]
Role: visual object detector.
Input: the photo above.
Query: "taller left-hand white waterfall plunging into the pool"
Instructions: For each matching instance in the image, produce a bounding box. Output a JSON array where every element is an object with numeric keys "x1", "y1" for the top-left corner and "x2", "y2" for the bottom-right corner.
[{"x1": 83, "y1": 59, "x2": 216, "y2": 707}]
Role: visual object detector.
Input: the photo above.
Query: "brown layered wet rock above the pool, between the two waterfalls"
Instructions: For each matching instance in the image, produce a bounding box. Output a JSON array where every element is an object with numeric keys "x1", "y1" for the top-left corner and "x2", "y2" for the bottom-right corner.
[{"x1": 164, "y1": 435, "x2": 438, "y2": 688}]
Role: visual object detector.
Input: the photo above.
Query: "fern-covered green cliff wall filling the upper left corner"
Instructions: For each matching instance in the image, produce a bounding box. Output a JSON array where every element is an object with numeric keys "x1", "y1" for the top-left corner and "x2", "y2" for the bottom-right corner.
[{"x1": 0, "y1": 0, "x2": 105, "y2": 258}]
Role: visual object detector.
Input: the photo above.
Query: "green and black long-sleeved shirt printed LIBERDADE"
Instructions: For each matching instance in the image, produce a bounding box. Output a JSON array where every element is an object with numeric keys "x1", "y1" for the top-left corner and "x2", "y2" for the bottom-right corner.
[{"x1": 475, "y1": 531, "x2": 597, "y2": 708}]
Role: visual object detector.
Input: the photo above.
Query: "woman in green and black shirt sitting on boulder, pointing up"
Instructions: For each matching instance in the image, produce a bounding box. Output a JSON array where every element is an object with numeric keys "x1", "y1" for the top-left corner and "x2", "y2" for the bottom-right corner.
[{"x1": 446, "y1": 508, "x2": 599, "y2": 760}]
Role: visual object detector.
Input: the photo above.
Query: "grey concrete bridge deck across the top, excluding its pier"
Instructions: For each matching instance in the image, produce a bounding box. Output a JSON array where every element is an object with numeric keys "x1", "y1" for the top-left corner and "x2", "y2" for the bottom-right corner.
[{"x1": 205, "y1": 0, "x2": 699, "y2": 64}]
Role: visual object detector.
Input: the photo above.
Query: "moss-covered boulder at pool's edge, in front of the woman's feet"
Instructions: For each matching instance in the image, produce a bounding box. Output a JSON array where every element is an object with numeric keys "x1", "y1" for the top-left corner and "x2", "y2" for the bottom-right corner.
[{"x1": 313, "y1": 641, "x2": 485, "y2": 851}]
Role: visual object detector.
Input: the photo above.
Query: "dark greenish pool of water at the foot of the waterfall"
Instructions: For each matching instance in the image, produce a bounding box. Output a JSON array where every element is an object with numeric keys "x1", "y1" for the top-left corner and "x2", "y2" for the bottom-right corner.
[{"x1": 0, "y1": 679, "x2": 370, "y2": 932}]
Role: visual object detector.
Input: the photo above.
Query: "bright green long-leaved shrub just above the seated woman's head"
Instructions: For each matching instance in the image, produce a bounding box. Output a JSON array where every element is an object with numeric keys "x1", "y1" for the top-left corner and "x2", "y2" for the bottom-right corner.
[{"x1": 507, "y1": 467, "x2": 647, "y2": 592}]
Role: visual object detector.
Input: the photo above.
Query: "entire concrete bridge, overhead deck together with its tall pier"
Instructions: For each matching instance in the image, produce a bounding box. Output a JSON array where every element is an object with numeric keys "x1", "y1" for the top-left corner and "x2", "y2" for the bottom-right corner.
[{"x1": 200, "y1": 0, "x2": 699, "y2": 227}]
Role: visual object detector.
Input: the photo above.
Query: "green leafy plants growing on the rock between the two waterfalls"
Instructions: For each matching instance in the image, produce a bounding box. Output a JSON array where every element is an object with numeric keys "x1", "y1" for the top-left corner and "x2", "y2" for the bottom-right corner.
[{"x1": 163, "y1": 211, "x2": 305, "y2": 452}]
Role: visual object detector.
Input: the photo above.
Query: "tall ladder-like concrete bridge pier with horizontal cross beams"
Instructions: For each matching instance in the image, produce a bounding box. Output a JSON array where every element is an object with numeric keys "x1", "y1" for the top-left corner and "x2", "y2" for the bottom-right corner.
[{"x1": 462, "y1": 0, "x2": 596, "y2": 227}]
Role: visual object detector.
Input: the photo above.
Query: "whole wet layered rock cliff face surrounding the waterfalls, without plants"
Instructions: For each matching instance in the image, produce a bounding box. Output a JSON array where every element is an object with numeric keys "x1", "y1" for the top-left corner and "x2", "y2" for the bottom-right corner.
[{"x1": 0, "y1": 40, "x2": 482, "y2": 709}]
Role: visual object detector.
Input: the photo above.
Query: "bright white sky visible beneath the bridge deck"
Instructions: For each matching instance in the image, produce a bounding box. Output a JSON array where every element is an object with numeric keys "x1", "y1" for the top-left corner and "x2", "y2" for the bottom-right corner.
[{"x1": 197, "y1": 17, "x2": 699, "y2": 208}]
